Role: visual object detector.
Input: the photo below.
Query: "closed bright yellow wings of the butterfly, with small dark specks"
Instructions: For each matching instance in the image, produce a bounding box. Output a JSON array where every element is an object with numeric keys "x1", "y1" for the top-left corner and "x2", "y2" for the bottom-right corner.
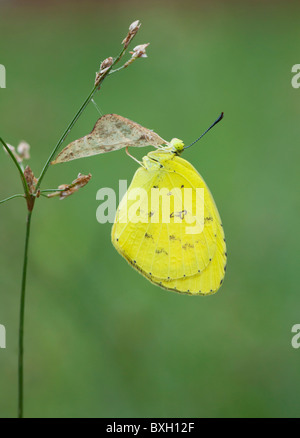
[{"x1": 112, "y1": 155, "x2": 226, "y2": 294}]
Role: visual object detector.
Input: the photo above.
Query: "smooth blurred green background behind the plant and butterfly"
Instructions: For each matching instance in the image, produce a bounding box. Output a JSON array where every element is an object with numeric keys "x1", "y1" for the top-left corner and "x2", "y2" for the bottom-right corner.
[{"x1": 0, "y1": 1, "x2": 300, "y2": 417}]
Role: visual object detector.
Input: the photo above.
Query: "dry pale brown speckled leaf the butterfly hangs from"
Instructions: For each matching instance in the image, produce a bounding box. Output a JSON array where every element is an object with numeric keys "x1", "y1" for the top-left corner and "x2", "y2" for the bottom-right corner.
[{"x1": 51, "y1": 114, "x2": 166, "y2": 164}]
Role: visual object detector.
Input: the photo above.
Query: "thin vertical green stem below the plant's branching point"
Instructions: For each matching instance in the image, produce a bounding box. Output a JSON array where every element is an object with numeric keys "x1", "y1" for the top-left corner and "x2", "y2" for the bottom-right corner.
[{"x1": 18, "y1": 211, "x2": 32, "y2": 418}]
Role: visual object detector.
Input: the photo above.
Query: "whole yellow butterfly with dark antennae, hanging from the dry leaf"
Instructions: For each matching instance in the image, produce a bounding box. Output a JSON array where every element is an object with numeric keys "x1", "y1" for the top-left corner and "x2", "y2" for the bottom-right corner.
[{"x1": 112, "y1": 113, "x2": 227, "y2": 295}]
